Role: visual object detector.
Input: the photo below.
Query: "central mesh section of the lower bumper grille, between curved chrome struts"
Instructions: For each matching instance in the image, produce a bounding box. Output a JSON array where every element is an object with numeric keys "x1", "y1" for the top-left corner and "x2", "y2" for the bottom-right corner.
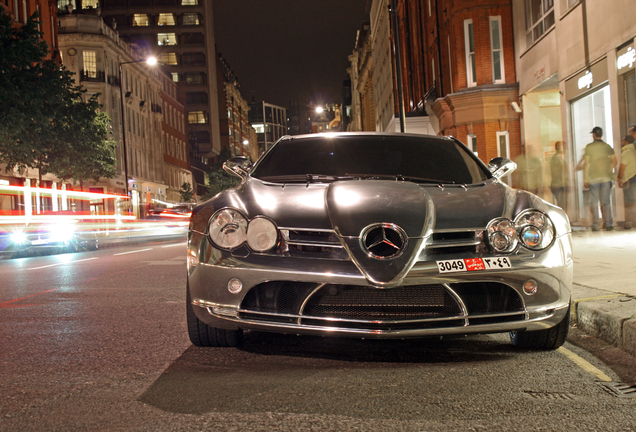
[{"x1": 303, "y1": 285, "x2": 461, "y2": 319}]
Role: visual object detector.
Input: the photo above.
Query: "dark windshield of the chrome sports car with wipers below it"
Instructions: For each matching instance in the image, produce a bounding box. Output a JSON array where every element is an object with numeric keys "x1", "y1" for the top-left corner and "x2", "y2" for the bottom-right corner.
[{"x1": 251, "y1": 135, "x2": 490, "y2": 184}]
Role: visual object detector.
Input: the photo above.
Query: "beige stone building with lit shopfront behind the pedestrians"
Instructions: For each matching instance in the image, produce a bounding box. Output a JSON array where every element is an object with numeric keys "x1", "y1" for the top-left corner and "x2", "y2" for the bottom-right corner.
[{"x1": 513, "y1": 0, "x2": 636, "y2": 225}]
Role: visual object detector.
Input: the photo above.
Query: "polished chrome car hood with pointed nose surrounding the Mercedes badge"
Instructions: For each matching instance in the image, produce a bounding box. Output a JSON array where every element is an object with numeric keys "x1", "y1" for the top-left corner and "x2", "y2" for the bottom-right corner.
[{"x1": 192, "y1": 178, "x2": 545, "y2": 286}]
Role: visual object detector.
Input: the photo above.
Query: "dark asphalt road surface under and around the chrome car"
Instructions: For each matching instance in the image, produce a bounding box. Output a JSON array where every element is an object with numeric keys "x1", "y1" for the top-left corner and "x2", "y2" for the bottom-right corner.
[{"x1": 0, "y1": 242, "x2": 636, "y2": 432}]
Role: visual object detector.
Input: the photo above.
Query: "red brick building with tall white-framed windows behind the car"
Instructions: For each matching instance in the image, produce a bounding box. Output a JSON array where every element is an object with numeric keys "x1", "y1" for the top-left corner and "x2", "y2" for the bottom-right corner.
[{"x1": 394, "y1": 0, "x2": 522, "y2": 162}]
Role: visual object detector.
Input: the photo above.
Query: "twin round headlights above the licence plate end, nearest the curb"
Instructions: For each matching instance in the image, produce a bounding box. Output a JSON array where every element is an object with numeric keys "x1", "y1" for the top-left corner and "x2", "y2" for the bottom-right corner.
[{"x1": 486, "y1": 210, "x2": 554, "y2": 253}]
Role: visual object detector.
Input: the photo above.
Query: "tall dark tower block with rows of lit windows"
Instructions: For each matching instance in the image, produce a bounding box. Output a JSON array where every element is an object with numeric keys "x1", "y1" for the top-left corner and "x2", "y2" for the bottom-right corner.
[{"x1": 100, "y1": 0, "x2": 221, "y2": 159}]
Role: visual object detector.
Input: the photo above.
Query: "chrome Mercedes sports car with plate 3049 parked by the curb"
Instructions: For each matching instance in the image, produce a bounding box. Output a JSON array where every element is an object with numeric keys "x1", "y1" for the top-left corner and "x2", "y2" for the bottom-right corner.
[{"x1": 187, "y1": 133, "x2": 573, "y2": 349}]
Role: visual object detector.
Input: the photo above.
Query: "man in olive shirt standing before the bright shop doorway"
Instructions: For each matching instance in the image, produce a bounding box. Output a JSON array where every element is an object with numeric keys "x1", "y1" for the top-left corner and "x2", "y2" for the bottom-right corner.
[{"x1": 583, "y1": 126, "x2": 616, "y2": 231}]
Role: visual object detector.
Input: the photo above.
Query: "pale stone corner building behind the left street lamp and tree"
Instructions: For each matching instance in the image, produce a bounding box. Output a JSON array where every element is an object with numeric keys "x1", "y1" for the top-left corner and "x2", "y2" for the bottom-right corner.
[{"x1": 58, "y1": 13, "x2": 175, "y2": 218}]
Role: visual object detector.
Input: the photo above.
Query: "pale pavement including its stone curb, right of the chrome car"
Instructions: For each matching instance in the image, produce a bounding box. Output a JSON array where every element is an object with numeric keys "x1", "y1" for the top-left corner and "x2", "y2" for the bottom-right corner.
[{"x1": 571, "y1": 228, "x2": 636, "y2": 355}]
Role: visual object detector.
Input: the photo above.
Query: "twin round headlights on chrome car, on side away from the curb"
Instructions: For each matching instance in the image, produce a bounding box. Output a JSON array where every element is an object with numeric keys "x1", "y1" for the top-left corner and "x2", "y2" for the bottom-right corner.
[{"x1": 208, "y1": 208, "x2": 278, "y2": 252}]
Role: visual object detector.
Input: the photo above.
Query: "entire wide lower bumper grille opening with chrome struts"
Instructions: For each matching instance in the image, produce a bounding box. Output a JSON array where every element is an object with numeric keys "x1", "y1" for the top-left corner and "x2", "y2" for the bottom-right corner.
[{"x1": 239, "y1": 281, "x2": 525, "y2": 330}]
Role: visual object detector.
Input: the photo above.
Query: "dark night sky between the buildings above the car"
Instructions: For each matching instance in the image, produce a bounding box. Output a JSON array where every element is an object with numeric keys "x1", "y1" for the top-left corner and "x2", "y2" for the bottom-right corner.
[{"x1": 213, "y1": 0, "x2": 369, "y2": 109}]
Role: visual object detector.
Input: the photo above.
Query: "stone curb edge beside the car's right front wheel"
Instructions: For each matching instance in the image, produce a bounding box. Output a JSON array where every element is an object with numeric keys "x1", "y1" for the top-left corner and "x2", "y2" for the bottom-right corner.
[{"x1": 572, "y1": 291, "x2": 636, "y2": 355}]
